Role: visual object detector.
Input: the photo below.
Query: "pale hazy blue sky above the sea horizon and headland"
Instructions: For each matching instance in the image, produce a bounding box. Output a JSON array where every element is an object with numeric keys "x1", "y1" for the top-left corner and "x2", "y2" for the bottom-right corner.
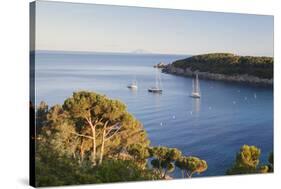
[{"x1": 36, "y1": 1, "x2": 273, "y2": 56}]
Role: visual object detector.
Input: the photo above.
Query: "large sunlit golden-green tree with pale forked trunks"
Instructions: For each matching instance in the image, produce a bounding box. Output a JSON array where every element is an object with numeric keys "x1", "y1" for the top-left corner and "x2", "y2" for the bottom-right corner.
[{"x1": 37, "y1": 91, "x2": 149, "y2": 166}]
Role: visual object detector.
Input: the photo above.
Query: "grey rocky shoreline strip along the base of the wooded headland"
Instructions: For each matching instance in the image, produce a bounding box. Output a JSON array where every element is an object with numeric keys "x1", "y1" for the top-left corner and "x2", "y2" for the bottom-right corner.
[{"x1": 162, "y1": 64, "x2": 273, "y2": 86}]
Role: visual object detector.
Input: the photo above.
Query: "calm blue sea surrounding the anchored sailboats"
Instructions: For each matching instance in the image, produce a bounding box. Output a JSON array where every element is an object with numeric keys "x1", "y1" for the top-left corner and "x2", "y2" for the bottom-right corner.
[{"x1": 35, "y1": 51, "x2": 273, "y2": 177}]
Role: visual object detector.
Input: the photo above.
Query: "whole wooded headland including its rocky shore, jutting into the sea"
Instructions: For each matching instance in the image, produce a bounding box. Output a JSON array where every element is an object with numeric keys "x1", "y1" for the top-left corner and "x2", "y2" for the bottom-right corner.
[{"x1": 161, "y1": 53, "x2": 273, "y2": 85}]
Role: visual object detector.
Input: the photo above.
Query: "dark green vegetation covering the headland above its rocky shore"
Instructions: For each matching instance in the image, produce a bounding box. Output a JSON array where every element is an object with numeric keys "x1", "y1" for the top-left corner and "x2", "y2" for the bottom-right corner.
[{"x1": 172, "y1": 53, "x2": 273, "y2": 79}]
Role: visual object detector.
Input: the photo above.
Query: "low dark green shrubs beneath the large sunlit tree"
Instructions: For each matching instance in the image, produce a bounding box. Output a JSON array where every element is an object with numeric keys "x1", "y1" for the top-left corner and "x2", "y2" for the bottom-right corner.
[{"x1": 36, "y1": 150, "x2": 155, "y2": 186}]
